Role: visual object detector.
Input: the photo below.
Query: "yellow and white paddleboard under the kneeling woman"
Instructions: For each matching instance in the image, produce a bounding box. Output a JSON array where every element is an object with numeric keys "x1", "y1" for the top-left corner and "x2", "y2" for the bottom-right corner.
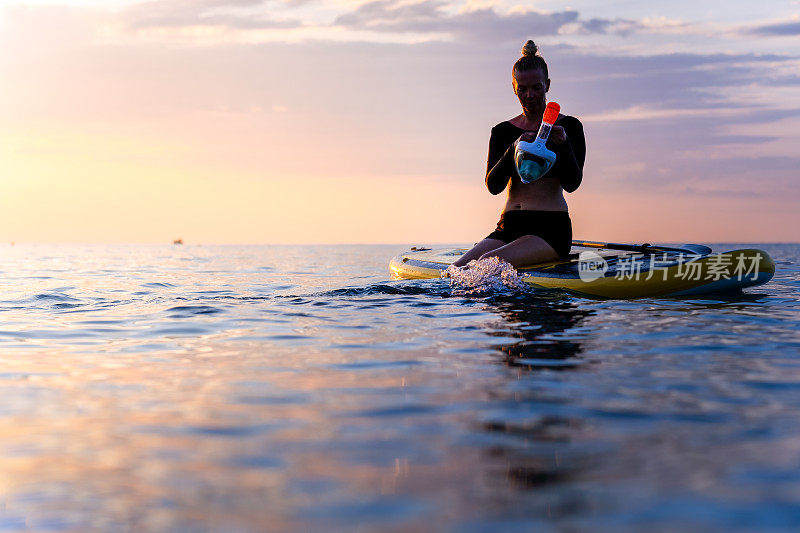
[{"x1": 389, "y1": 241, "x2": 775, "y2": 298}]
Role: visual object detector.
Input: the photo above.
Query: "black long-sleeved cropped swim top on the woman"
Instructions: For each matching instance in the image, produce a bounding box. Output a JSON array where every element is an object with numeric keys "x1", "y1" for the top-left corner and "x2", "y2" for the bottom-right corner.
[{"x1": 486, "y1": 115, "x2": 586, "y2": 192}]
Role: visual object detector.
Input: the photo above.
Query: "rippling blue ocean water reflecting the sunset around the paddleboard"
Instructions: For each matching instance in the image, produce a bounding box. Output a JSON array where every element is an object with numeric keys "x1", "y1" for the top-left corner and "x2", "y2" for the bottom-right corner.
[{"x1": 0, "y1": 244, "x2": 800, "y2": 532}]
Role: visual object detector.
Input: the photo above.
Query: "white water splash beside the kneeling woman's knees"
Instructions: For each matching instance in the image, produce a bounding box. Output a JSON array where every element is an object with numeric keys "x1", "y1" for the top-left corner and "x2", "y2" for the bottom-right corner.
[{"x1": 442, "y1": 257, "x2": 527, "y2": 294}]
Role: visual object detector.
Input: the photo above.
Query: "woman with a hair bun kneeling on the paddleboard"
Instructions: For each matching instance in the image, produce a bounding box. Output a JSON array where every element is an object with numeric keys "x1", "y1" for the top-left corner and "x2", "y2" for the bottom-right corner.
[{"x1": 454, "y1": 41, "x2": 586, "y2": 266}]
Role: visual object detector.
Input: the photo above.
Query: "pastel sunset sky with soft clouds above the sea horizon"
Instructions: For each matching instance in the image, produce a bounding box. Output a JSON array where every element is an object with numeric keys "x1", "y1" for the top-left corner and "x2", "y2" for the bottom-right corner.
[{"x1": 0, "y1": 0, "x2": 800, "y2": 244}]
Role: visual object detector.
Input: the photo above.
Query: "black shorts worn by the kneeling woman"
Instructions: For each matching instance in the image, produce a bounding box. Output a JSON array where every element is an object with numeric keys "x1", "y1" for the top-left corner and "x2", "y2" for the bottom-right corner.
[{"x1": 486, "y1": 210, "x2": 572, "y2": 257}]
